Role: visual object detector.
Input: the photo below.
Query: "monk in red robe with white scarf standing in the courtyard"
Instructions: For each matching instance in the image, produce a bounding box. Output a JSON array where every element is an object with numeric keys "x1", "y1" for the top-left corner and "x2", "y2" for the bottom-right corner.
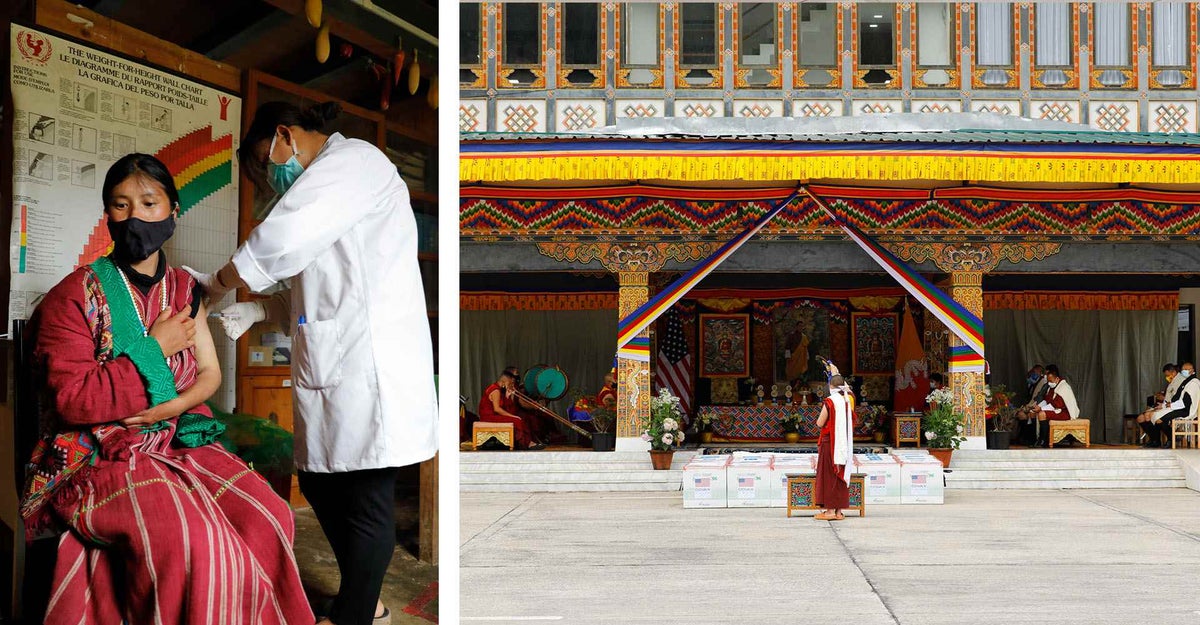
[{"x1": 812, "y1": 369, "x2": 854, "y2": 521}]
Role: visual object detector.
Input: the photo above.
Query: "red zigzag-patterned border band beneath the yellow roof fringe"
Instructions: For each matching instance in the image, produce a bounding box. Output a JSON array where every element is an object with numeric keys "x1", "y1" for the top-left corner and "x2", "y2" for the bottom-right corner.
[{"x1": 460, "y1": 186, "x2": 1200, "y2": 236}]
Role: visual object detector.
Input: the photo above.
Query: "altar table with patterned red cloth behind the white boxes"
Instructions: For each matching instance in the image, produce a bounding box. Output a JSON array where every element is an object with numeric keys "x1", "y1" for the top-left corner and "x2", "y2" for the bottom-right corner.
[{"x1": 698, "y1": 404, "x2": 871, "y2": 443}]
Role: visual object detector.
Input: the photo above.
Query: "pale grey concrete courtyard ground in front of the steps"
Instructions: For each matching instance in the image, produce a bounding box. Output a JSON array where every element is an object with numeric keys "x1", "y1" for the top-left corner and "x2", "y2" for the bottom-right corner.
[{"x1": 460, "y1": 488, "x2": 1200, "y2": 625}]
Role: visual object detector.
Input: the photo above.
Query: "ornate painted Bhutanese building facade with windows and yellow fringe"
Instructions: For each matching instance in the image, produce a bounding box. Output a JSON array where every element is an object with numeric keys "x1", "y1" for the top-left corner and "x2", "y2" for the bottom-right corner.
[{"x1": 460, "y1": 2, "x2": 1200, "y2": 445}]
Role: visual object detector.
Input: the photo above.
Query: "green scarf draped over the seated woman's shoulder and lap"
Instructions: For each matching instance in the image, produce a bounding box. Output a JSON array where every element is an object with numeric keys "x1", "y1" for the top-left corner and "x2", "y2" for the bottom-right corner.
[{"x1": 91, "y1": 257, "x2": 224, "y2": 447}]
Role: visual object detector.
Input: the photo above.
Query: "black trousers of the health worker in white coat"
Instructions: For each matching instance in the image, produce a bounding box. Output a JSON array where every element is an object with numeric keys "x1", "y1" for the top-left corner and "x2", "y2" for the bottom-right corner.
[{"x1": 299, "y1": 467, "x2": 400, "y2": 625}]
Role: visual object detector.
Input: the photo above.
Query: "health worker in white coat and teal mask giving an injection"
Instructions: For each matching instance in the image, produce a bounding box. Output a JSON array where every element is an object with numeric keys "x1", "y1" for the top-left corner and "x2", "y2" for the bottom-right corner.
[{"x1": 183, "y1": 102, "x2": 437, "y2": 625}]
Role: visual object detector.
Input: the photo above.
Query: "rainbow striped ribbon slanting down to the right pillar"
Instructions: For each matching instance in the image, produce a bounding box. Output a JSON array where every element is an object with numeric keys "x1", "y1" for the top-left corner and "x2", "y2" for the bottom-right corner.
[{"x1": 803, "y1": 188, "x2": 983, "y2": 357}]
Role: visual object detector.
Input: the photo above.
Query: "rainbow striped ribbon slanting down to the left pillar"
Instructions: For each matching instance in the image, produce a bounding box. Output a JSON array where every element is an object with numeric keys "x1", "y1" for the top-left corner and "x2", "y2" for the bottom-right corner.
[{"x1": 617, "y1": 190, "x2": 800, "y2": 362}]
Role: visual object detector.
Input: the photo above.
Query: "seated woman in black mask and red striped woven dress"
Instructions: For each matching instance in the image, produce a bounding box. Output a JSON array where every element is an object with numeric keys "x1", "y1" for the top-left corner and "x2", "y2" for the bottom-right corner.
[{"x1": 20, "y1": 154, "x2": 314, "y2": 625}]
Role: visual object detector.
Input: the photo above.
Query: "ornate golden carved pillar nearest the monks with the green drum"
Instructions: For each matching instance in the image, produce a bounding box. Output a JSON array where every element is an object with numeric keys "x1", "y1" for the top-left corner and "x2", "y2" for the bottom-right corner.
[{"x1": 617, "y1": 271, "x2": 650, "y2": 451}]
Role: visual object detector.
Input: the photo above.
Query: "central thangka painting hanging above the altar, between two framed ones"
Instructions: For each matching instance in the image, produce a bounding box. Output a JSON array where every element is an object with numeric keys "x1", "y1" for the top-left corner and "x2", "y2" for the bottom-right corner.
[{"x1": 770, "y1": 300, "x2": 830, "y2": 389}]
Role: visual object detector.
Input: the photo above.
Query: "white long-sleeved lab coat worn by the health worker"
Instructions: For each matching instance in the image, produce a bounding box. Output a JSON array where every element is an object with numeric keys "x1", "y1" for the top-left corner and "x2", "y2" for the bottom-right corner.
[{"x1": 233, "y1": 133, "x2": 438, "y2": 473}]
